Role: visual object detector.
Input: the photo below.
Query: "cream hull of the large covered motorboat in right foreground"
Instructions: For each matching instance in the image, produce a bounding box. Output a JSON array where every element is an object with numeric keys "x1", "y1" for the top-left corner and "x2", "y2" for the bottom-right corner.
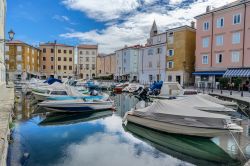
[{"x1": 125, "y1": 114, "x2": 237, "y2": 138}]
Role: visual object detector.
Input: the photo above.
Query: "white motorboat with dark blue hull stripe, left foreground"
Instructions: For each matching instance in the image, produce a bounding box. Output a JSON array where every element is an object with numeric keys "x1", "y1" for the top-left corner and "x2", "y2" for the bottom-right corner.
[{"x1": 38, "y1": 99, "x2": 114, "y2": 112}]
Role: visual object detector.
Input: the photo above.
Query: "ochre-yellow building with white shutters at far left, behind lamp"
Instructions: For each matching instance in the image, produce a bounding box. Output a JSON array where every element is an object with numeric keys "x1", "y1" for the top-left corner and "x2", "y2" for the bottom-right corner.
[{"x1": 5, "y1": 40, "x2": 41, "y2": 80}]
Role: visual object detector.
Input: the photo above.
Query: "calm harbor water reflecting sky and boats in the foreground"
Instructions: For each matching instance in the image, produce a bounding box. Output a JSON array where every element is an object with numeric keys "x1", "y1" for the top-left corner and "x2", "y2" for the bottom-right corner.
[{"x1": 8, "y1": 93, "x2": 250, "y2": 166}]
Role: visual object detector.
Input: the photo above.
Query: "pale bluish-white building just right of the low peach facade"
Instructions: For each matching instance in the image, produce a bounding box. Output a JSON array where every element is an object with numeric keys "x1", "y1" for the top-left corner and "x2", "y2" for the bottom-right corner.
[{"x1": 115, "y1": 45, "x2": 141, "y2": 81}]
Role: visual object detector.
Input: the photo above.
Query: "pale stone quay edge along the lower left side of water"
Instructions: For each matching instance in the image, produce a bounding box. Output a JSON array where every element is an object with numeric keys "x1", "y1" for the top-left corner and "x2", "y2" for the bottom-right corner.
[{"x1": 0, "y1": 85, "x2": 14, "y2": 166}]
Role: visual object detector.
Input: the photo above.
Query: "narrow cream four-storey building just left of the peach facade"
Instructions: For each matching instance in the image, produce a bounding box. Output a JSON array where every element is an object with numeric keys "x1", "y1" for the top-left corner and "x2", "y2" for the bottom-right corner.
[{"x1": 77, "y1": 45, "x2": 98, "y2": 80}]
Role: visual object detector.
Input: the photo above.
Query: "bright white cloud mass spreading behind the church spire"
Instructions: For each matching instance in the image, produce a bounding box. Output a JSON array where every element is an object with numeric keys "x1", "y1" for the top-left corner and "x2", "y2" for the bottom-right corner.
[{"x1": 60, "y1": 0, "x2": 238, "y2": 53}]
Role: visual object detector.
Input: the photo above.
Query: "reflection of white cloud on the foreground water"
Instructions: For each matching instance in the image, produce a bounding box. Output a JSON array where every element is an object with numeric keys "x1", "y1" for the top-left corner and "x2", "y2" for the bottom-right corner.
[{"x1": 53, "y1": 133, "x2": 192, "y2": 166}]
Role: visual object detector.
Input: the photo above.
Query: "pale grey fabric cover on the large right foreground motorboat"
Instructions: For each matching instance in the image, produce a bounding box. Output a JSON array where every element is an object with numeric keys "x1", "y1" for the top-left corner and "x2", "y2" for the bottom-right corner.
[{"x1": 132, "y1": 100, "x2": 231, "y2": 129}]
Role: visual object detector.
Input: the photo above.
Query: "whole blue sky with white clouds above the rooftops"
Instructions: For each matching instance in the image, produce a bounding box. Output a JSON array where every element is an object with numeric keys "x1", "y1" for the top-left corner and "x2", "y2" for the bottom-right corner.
[{"x1": 6, "y1": 0, "x2": 234, "y2": 53}]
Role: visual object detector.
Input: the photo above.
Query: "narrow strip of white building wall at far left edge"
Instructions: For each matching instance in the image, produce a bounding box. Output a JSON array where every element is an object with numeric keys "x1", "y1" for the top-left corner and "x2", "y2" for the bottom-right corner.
[{"x1": 0, "y1": 0, "x2": 6, "y2": 85}]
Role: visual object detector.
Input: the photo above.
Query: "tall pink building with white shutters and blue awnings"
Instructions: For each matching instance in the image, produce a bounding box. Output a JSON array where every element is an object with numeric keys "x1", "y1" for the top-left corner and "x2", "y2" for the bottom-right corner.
[{"x1": 193, "y1": 0, "x2": 250, "y2": 87}]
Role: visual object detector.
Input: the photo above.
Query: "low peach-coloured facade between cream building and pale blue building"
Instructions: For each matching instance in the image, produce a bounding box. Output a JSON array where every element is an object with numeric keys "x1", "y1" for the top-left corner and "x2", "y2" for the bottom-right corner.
[{"x1": 96, "y1": 53, "x2": 116, "y2": 77}]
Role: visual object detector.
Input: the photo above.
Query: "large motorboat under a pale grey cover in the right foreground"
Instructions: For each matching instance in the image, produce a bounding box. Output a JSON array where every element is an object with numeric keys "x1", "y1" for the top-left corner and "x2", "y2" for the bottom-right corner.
[{"x1": 123, "y1": 100, "x2": 243, "y2": 137}]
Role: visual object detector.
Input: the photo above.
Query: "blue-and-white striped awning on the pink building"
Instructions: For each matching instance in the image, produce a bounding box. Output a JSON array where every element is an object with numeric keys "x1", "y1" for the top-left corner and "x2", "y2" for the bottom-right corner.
[{"x1": 223, "y1": 68, "x2": 250, "y2": 77}]
